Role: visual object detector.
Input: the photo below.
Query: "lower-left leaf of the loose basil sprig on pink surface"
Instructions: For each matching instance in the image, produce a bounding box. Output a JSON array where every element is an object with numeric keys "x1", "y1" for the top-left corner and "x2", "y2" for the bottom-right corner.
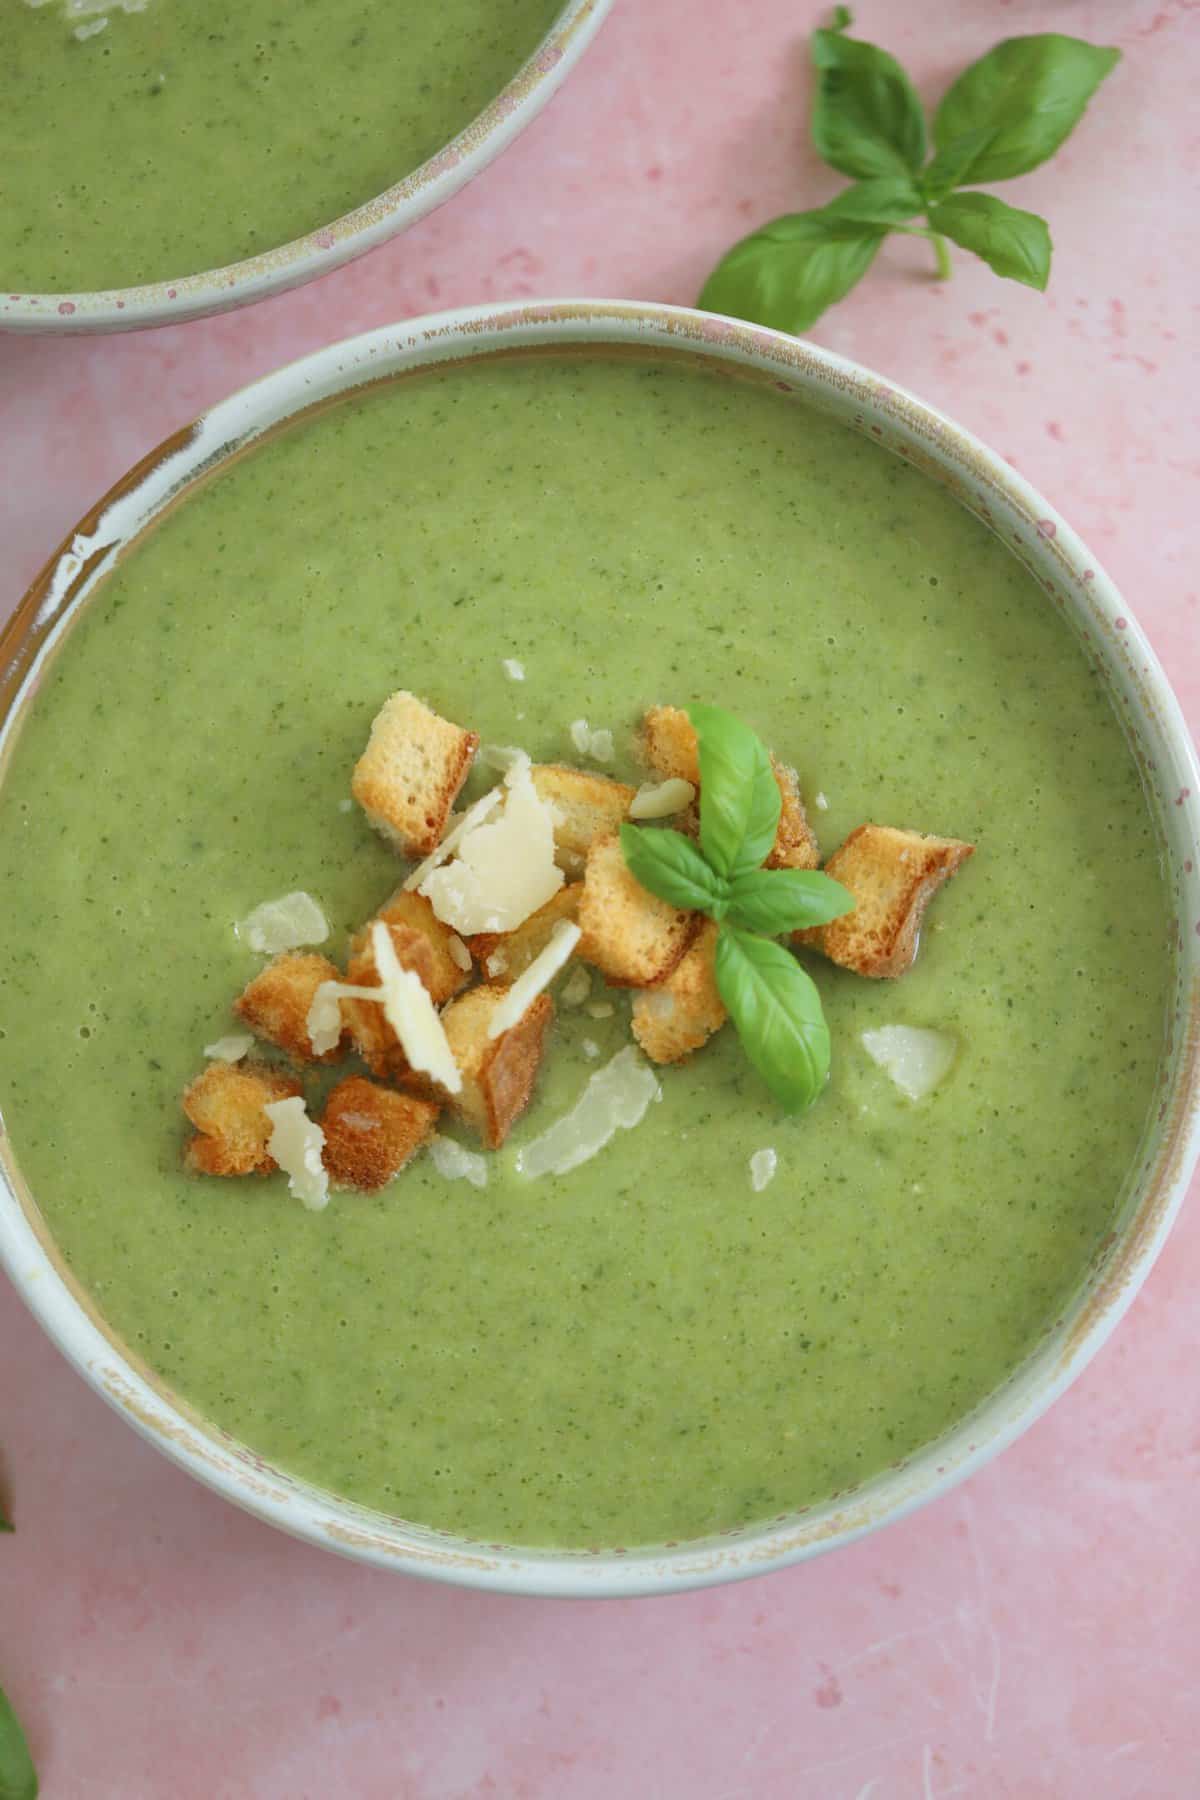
[{"x1": 696, "y1": 209, "x2": 885, "y2": 337}]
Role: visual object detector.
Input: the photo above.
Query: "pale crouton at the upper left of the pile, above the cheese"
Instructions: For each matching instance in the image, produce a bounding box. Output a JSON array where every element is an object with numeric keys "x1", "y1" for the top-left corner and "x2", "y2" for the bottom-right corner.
[{"x1": 351, "y1": 689, "x2": 479, "y2": 857}]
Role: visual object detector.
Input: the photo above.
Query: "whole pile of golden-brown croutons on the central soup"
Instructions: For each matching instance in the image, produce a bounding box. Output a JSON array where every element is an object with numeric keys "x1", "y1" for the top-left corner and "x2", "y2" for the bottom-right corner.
[{"x1": 184, "y1": 693, "x2": 972, "y2": 1192}]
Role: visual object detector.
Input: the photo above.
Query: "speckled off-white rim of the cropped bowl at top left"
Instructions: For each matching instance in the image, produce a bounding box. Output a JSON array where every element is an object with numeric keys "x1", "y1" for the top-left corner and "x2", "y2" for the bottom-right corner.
[{"x1": 0, "y1": 0, "x2": 612, "y2": 331}]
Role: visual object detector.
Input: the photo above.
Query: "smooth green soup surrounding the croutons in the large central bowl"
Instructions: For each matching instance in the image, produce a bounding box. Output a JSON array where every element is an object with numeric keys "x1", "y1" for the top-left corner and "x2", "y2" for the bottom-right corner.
[{"x1": 0, "y1": 356, "x2": 1168, "y2": 1546}]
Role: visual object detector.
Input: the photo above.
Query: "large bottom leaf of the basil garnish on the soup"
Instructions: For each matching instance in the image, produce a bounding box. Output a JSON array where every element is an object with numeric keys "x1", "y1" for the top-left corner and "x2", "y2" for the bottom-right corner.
[{"x1": 716, "y1": 923, "x2": 829, "y2": 1112}]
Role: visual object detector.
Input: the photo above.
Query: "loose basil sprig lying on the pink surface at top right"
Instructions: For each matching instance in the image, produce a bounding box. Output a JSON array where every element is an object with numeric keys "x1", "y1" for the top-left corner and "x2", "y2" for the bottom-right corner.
[{"x1": 696, "y1": 5, "x2": 1121, "y2": 333}]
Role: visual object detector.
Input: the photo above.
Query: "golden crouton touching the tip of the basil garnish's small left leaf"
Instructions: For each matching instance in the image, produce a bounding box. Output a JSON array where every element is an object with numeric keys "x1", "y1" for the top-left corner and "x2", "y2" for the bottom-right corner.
[{"x1": 578, "y1": 837, "x2": 700, "y2": 988}]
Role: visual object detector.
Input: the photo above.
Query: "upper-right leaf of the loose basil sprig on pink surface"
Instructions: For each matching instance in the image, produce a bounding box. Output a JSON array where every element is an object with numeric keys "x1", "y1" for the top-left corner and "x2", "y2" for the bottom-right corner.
[{"x1": 934, "y1": 31, "x2": 1121, "y2": 182}]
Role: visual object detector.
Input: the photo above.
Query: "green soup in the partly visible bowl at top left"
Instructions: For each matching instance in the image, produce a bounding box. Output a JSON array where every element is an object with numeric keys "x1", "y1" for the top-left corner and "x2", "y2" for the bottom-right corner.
[{"x1": 0, "y1": 0, "x2": 561, "y2": 293}]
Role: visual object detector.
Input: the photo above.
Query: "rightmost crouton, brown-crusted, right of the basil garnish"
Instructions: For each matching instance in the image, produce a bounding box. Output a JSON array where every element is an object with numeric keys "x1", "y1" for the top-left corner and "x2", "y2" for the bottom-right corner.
[{"x1": 793, "y1": 824, "x2": 975, "y2": 979}]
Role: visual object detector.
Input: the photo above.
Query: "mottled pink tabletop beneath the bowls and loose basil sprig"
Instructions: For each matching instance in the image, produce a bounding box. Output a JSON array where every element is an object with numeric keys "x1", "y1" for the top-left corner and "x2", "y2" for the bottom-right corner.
[{"x1": 0, "y1": 0, "x2": 1200, "y2": 1800}]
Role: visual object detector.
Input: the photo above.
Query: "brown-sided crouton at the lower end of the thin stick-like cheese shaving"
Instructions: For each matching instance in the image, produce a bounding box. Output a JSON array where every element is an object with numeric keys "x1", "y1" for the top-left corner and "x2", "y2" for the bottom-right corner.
[{"x1": 443, "y1": 983, "x2": 554, "y2": 1150}]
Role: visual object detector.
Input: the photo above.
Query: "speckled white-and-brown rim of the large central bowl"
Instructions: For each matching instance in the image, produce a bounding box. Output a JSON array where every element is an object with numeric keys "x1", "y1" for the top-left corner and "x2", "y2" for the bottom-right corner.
[{"x1": 0, "y1": 301, "x2": 1200, "y2": 1597}]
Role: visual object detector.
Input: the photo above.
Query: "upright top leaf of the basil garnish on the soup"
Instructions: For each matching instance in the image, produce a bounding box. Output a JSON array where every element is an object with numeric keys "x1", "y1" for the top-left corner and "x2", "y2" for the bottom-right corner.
[{"x1": 687, "y1": 706, "x2": 783, "y2": 875}]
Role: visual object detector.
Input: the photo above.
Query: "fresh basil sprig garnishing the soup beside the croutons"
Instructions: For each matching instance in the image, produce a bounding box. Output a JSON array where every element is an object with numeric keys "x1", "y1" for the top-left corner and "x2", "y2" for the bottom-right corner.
[{"x1": 621, "y1": 706, "x2": 855, "y2": 1112}]
